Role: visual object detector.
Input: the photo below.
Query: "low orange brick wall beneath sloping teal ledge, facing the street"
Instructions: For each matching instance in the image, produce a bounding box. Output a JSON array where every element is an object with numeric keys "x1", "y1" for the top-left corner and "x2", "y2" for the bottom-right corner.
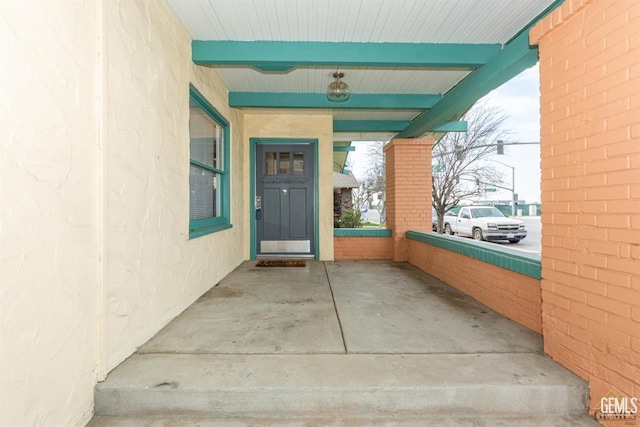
[{"x1": 409, "y1": 240, "x2": 542, "y2": 333}]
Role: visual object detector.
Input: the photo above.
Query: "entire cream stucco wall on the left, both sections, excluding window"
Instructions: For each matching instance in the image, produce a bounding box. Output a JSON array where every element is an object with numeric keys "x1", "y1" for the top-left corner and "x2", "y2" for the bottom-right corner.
[{"x1": 0, "y1": 0, "x2": 246, "y2": 426}]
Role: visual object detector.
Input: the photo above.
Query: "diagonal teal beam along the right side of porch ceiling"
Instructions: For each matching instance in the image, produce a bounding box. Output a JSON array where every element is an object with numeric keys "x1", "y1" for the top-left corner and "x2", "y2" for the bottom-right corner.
[{"x1": 397, "y1": 31, "x2": 538, "y2": 138}]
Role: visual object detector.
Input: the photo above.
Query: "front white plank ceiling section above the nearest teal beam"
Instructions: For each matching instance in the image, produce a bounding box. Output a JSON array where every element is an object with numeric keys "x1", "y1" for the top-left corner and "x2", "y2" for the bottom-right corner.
[{"x1": 168, "y1": 0, "x2": 552, "y2": 44}]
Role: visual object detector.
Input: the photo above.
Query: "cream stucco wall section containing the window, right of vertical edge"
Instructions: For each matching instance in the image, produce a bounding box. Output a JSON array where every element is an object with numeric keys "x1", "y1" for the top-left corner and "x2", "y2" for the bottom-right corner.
[{"x1": 105, "y1": 0, "x2": 245, "y2": 369}]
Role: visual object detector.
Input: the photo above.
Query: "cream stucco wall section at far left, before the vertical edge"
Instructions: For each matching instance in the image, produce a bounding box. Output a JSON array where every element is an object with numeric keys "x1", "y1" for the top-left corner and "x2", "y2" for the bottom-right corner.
[{"x1": 0, "y1": 1, "x2": 99, "y2": 426}]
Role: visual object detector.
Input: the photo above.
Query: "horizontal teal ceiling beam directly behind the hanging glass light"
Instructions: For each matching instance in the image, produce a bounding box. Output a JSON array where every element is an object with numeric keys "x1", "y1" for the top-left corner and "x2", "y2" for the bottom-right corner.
[{"x1": 229, "y1": 92, "x2": 442, "y2": 110}]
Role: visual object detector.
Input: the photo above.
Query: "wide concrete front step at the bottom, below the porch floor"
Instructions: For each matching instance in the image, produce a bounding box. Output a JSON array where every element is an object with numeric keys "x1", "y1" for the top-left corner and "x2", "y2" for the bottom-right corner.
[{"x1": 95, "y1": 353, "x2": 587, "y2": 425}]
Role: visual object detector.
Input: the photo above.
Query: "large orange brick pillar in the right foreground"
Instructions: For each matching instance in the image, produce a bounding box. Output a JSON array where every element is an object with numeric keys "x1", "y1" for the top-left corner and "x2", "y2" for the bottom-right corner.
[{"x1": 531, "y1": 0, "x2": 640, "y2": 409}]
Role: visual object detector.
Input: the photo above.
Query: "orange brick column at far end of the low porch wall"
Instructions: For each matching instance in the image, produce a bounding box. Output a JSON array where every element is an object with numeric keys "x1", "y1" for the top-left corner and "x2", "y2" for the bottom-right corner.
[{"x1": 384, "y1": 139, "x2": 433, "y2": 261}]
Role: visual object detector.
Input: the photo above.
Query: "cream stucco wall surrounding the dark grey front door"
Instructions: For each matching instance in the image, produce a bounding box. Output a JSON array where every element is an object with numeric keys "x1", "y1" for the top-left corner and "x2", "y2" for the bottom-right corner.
[{"x1": 244, "y1": 111, "x2": 333, "y2": 261}]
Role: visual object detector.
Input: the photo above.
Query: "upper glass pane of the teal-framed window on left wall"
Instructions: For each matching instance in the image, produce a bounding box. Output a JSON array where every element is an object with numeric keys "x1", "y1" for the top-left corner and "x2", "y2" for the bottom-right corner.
[{"x1": 189, "y1": 104, "x2": 222, "y2": 169}]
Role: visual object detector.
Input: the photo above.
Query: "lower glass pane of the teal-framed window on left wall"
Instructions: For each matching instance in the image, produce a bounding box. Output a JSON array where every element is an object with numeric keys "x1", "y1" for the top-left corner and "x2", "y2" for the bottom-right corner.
[{"x1": 189, "y1": 165, "x2": 220, "y2": 219}]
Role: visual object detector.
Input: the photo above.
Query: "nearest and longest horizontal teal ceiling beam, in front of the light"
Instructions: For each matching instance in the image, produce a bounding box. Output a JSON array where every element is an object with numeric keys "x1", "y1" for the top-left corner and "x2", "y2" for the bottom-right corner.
[{"x1": 191, "y1": 40, "x2": 501, "y2": 72}]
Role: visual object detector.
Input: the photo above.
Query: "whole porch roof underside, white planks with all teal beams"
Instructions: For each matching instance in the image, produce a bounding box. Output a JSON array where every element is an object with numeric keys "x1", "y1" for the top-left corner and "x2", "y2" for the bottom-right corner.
[{"x1": 174, "y1": 0, "x2": 563, "y2": 140}]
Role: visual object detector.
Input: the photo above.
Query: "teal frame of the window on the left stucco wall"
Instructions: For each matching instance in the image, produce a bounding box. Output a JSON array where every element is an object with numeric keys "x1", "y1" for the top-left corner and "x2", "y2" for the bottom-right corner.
[{"x1": 189, "y1": 84, "x2": 232, "y2": 239}]
